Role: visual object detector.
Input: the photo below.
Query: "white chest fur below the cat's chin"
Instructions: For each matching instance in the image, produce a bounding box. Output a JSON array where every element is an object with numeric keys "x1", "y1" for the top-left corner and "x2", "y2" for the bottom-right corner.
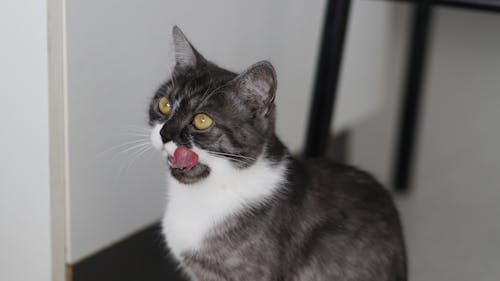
[{"x1": 163, "y1": 154, "x2": 285, "y2": 259}]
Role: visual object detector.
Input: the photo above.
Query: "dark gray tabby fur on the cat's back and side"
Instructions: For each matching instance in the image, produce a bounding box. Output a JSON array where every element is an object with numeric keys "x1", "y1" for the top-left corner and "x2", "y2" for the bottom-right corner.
[{"x1": 176, "y1": 160, "x2": 406, "y2": 281}]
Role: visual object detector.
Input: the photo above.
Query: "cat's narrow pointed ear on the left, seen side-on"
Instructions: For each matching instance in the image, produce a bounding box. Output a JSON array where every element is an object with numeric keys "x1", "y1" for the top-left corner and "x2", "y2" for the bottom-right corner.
[{"x1": 172, "y1": 25, "x2": 203, "y2": 69}]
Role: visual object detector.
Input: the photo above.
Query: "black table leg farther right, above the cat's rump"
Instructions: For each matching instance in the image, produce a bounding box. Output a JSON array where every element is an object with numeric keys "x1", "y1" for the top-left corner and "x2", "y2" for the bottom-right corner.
[{"x1": 392, "y1": 4, "x2": 432, "y2": 191}]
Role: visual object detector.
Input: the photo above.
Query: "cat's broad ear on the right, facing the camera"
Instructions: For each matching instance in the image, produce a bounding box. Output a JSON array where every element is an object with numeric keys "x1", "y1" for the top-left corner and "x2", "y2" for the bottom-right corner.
[{"x1": 235, "y1": 61, "x2": 276, "y2": 114}]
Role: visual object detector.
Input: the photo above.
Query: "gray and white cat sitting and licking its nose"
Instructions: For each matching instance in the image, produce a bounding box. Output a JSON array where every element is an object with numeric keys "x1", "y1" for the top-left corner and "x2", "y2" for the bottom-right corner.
[{"x1": 149, "y1": 27, "x2": 407, "y2": 281}]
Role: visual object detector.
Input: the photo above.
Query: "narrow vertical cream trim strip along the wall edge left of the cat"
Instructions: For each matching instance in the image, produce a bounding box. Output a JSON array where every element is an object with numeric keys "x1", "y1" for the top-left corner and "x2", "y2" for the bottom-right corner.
[{"x1": 47, "y1": 0, "x2": 68, "y2": 281}]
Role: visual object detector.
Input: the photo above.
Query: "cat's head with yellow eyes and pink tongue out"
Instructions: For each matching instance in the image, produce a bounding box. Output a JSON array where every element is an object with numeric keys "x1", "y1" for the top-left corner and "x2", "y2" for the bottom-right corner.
[{"x1": 149, "y1": 27, "x2": 282, "y2": 184}]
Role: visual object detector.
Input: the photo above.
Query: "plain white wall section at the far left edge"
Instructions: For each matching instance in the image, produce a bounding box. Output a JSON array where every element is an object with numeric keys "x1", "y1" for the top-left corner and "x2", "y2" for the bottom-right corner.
[{"x1": 0, "y1": 0, "x2": 51, "y2": 281}]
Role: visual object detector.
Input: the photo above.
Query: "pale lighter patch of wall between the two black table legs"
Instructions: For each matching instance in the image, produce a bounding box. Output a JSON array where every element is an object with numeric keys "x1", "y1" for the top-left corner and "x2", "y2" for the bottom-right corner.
[{"x1": 332, "y1": 0, "x2": 401, "y2": 130}]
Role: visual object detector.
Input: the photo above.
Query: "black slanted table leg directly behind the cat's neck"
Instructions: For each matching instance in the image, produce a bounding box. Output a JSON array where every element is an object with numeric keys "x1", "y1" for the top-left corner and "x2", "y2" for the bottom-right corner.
[{"x1": 304, "y1": 0, "x2": 351, "y2": 157}]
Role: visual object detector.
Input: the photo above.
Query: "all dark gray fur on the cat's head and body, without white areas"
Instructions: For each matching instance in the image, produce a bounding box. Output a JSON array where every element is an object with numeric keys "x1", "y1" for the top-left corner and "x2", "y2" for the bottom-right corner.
[{"x1": 150, "y1": 27, "x2": 406, "y2": 281}]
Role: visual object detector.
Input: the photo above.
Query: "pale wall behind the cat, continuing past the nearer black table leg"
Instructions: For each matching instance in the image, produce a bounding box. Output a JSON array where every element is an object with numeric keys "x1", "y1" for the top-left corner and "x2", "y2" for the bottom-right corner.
[{"x1": 67, "y1": 0, "x2": 398, "y2": 262}]
